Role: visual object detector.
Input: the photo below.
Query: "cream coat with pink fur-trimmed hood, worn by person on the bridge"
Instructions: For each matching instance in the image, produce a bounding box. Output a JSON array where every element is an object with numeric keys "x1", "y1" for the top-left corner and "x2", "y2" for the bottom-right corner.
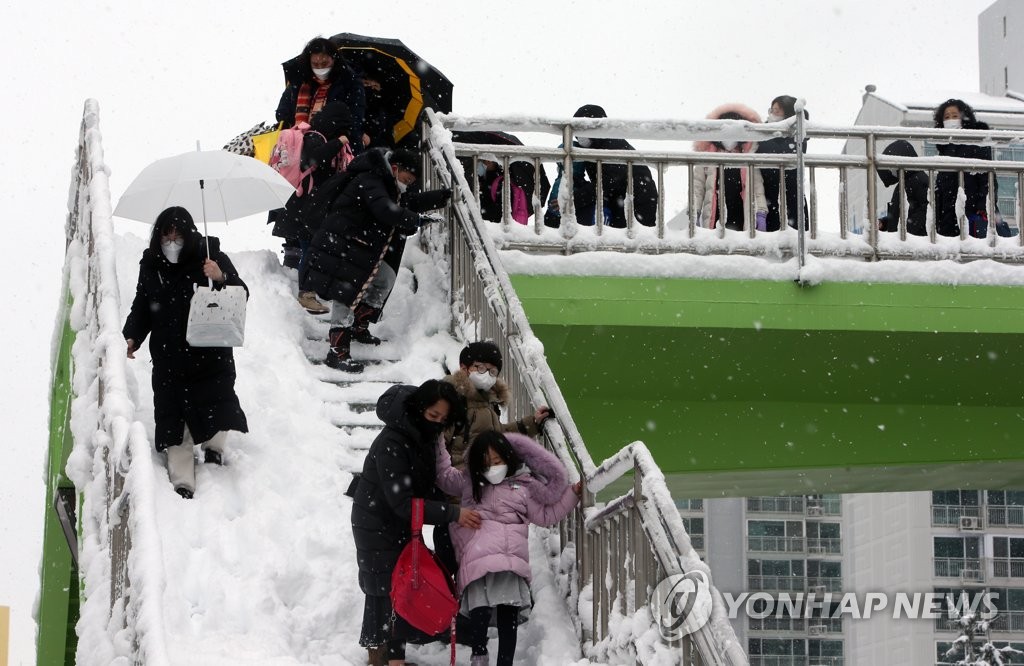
[{"x1": 690, "y1": 103, "x2": 768, "y2": 228}]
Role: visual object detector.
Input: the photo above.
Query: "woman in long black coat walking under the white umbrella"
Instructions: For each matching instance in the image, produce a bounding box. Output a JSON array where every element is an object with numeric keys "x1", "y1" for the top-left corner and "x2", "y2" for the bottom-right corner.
[{"x1": 123, "y1": 207, "x2": 249, "y2": 499}]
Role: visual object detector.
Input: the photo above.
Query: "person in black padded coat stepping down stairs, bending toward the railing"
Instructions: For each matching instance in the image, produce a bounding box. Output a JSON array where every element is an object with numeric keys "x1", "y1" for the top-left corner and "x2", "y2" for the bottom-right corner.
[{"x1": 299, "y1": 149, "x2": 452, "y2": 372}]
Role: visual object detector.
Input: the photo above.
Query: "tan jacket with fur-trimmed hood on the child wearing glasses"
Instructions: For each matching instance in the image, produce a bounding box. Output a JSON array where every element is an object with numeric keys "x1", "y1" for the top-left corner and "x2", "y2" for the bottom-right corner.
[{"x1": 444, "y1": 369, "x2": 540, "y2": 467}]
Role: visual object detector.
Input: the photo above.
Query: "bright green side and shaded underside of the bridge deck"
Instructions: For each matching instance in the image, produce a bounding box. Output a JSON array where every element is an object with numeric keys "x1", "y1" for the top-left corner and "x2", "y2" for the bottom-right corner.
[{"x1": 513, "y1": 276, "x2": 1024, "y2": 497}]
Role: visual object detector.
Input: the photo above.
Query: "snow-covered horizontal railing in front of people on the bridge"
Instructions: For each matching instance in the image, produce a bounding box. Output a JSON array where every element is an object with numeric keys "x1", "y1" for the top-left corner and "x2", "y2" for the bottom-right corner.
[{"x1": 440, "y1": 115, "x2": 1024, "y2": 264}]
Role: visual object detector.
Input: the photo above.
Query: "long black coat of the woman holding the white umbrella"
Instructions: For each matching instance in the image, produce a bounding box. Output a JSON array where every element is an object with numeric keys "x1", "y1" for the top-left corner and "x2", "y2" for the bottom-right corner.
[{"x1": 123, "y1": 237, "x2": 249, "y2": 451}]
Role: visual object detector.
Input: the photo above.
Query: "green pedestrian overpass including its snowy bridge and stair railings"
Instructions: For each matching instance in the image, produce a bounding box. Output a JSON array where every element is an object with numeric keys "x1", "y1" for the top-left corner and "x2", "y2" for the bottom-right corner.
[{"x1": 39, "y1": 101, "x2": 1024, "y2": 665}]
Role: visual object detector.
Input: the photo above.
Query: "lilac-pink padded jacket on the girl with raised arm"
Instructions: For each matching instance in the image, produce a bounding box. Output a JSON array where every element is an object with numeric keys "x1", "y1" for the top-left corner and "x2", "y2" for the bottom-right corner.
[{"x1": 437, "y1": 433, "x2": 579, "y2": 594}]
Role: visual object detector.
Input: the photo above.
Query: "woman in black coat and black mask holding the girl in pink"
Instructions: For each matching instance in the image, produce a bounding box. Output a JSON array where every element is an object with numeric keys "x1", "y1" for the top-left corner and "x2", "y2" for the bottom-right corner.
[{"x1": 352, "y1": 379, "x2": 480, "y2": 663}]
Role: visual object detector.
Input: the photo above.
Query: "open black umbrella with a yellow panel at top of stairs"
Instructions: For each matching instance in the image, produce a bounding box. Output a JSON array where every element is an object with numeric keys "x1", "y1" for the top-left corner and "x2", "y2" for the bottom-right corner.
[{"x1": 331, "y1": 33, "x2": 453, "y2": 143}]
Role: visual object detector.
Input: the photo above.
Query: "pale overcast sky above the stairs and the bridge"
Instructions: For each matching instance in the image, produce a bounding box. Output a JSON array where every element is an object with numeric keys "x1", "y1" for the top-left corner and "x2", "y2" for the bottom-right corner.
[{"x1": 0, "y1": 0, "x2": 991, "y2": 665}]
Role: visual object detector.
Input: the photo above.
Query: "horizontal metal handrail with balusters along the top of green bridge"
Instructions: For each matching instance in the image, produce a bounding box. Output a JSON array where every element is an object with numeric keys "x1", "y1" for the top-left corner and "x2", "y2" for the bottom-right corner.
[{"x1": 439, "y1": 115, "x2": 1024, "y2": 265}]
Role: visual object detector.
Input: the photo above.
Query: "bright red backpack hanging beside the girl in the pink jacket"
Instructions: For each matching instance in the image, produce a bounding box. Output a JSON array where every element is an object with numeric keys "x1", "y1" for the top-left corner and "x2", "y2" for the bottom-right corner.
[{"x1": 391, "y1": 499, "x2": 459, "y2": 649}]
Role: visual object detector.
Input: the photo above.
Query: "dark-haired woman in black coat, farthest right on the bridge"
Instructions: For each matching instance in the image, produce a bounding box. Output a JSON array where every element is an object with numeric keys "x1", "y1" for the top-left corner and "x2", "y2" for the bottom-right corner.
[{"x1": 933, "y1": 99, "x2": 992, "y2": 238}]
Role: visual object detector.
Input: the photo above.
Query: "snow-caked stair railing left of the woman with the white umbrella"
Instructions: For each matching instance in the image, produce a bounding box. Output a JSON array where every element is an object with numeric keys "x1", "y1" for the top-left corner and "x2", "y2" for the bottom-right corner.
[{"x1": 63, "y1": 99, "x2": 169, "y2": 666}]
